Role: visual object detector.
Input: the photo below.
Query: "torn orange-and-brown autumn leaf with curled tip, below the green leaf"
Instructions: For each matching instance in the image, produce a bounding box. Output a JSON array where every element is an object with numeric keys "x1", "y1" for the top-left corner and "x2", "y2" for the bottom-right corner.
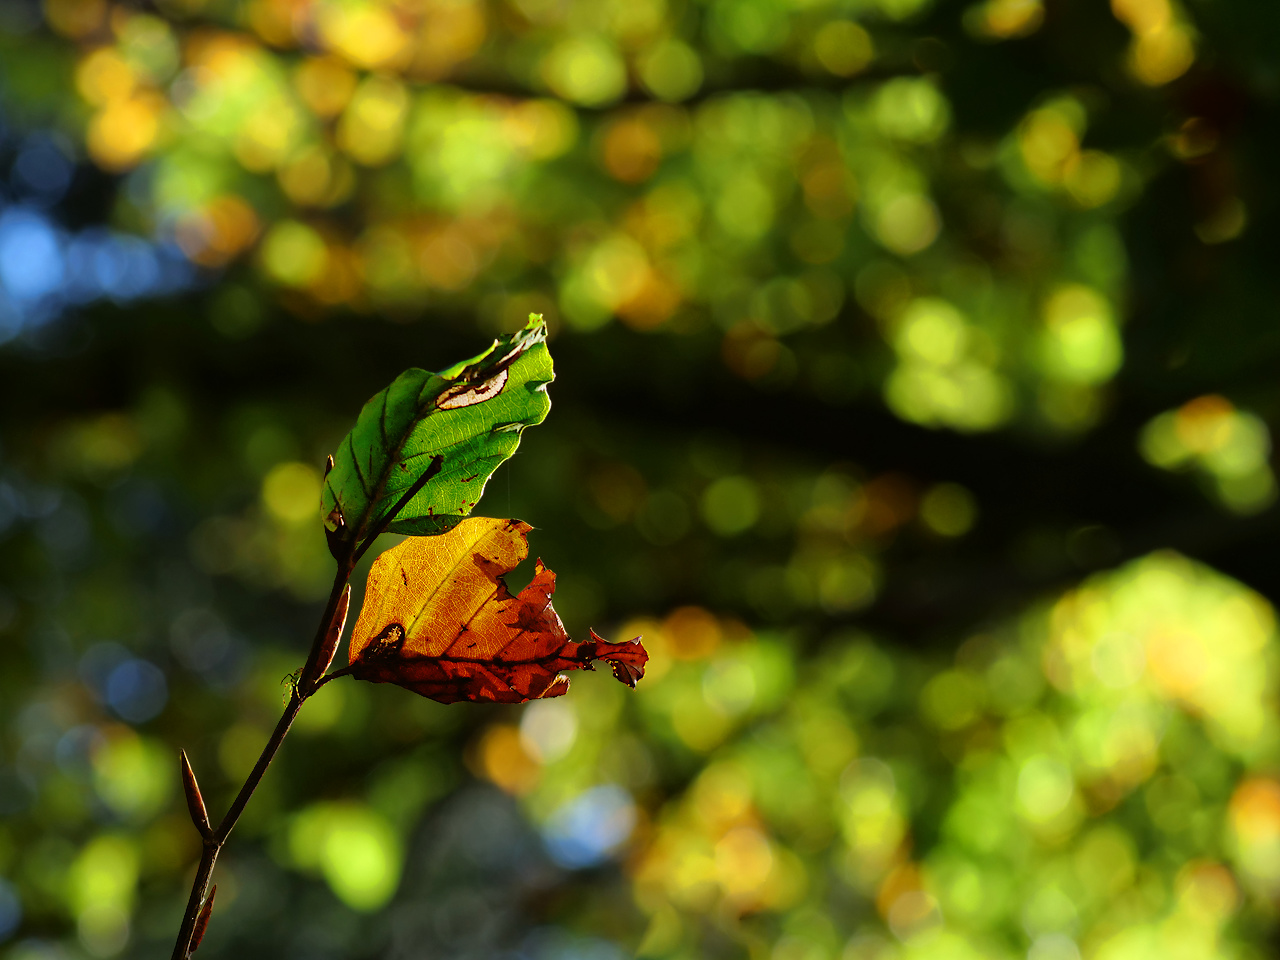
[{"x1": 349, "y1": 517, "x2": 649, "y2": 703}]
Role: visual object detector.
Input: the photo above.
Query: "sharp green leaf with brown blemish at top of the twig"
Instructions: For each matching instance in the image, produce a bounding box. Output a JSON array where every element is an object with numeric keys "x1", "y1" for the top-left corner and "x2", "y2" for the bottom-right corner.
[{"x1": 320, "y1": 320, "x2": 554, "y2": 544}]
